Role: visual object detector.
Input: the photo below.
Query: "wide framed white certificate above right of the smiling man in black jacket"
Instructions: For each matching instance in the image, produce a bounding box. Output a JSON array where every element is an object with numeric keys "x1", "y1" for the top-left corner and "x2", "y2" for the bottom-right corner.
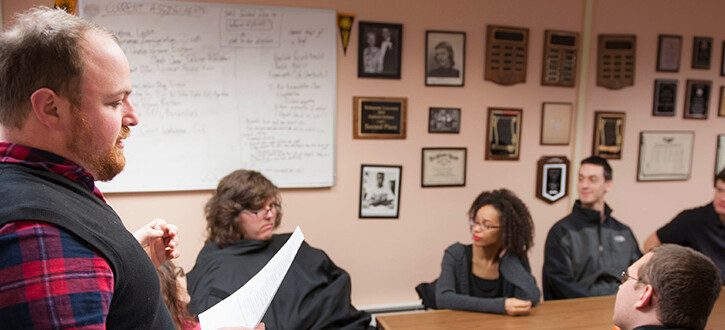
[{"x1": 637, "y1": 131, "x2": 695, "y2": 181}]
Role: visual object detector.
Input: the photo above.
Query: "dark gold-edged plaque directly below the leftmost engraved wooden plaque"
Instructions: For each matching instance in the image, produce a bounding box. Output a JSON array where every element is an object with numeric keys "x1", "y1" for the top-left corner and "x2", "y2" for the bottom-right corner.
[{"x1": 485, "y1": 108, "x2": 522, "y2": 160}]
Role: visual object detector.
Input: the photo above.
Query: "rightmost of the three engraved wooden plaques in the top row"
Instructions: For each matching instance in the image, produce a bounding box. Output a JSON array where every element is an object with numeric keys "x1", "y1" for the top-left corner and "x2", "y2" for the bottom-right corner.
[{"x1": 597, "y1": 34, "x2": 637, "y2": 89}]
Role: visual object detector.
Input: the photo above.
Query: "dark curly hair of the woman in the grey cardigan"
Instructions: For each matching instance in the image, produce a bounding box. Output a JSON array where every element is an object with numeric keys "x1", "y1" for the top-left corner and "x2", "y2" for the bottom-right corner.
[{"x1": 468, "y1": 189, "x2": 534, "y2": 258}]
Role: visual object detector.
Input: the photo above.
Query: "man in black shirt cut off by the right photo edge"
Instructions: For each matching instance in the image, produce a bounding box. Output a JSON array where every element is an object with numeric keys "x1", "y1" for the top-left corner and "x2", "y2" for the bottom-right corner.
[{"x1": 644, "y1": 169, "x2": 725, "y2": 281}]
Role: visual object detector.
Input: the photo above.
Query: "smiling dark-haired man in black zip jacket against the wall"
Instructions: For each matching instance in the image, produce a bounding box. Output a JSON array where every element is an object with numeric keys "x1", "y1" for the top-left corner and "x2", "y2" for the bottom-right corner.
[{"x1": 543, "y1": 156, "x2": 642, "y2": 300}]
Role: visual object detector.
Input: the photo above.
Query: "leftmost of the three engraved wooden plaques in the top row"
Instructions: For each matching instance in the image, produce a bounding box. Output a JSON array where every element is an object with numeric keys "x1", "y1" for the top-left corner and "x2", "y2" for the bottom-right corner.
[{"x1": 485, "y1": 25, "x2": 529, "y2": 85}]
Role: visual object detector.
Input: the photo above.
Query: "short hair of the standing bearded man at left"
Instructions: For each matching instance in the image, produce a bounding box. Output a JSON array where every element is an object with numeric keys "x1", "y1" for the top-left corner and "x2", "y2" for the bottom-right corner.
[{"x1": 0, "y1": 7, "x2": 115, "y2": 128}]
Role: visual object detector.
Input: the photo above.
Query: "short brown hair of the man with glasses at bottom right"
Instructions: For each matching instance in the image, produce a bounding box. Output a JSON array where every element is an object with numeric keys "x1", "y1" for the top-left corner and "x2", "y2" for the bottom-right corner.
[{"x1": 638, "y1": 244, "x2": 722, "y2": 329}]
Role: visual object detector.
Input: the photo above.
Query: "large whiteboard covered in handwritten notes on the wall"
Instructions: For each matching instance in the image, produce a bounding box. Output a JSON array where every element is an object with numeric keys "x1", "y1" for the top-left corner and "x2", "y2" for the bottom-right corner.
[{"x1": 79, "y1": 0, "x2": 337, "y2": 192}]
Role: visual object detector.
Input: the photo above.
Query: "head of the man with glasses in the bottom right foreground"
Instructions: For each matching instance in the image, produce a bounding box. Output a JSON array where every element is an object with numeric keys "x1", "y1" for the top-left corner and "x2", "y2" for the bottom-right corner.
[{"x1": 613, "y1": 244, "x2": 722, "y2": 330}]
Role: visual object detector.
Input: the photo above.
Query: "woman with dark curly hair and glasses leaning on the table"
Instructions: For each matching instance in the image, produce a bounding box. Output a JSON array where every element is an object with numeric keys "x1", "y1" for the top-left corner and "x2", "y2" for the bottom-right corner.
[{"x1": 416, "y1": 189, "x2": 541, "y2": 315}]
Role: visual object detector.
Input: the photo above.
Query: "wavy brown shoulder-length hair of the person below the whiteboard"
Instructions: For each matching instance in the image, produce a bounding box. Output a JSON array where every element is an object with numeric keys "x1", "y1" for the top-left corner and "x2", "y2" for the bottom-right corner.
[{"x1": 204, "y1": 170, "x2": 282, "y2": 249}]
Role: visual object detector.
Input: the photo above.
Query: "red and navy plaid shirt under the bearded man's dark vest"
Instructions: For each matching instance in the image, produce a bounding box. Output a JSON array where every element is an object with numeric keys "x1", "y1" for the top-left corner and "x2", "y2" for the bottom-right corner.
[{"x1": 0, "y1": 142, "x2": 113, "y2": 329}]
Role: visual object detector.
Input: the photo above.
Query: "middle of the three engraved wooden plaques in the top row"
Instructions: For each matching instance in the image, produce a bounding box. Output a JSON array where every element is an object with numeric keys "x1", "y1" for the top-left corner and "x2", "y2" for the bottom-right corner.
[{"x1": 541, "y1": 30, "x2": 579, "y2": 87}]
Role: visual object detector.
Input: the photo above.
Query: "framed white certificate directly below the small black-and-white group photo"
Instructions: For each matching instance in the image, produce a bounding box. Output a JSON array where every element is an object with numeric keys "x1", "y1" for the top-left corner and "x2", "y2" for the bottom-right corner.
[{"x1": 420, "y1": 148, "x2": 467, "y2": 187}]
